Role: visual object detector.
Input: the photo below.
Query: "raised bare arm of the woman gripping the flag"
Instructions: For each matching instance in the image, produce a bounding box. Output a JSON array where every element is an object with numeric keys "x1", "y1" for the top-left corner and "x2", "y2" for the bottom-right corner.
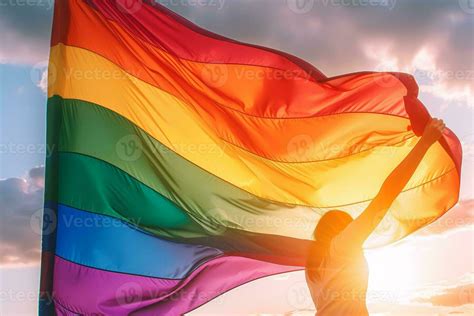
[{"x1": 338, "y1": 119, "x2": 445, "y2": 249}]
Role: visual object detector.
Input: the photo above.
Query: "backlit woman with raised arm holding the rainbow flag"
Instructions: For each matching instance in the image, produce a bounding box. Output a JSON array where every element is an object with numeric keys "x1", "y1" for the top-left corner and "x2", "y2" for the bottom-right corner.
[{"x1": 306, "y1": 119, "x2": 445, "y2": 316}]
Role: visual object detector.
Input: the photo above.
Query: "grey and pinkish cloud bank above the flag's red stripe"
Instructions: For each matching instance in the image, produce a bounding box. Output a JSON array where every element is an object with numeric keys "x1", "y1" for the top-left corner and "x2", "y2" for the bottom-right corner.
[{"x1": 171, "y1": 0, "x2": 474, "y2": 105}]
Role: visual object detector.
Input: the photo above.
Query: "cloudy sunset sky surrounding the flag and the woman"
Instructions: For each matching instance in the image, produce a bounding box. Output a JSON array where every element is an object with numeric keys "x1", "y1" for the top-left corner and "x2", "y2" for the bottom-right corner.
[{"x1": 0, "y1": 0, "x2": 474, "y2": 316}]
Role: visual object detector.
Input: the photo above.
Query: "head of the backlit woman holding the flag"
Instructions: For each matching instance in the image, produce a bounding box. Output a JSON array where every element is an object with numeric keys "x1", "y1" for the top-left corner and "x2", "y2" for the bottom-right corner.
[{"x1": 313, "y1": 210, "x2": 353, "y2": 244}]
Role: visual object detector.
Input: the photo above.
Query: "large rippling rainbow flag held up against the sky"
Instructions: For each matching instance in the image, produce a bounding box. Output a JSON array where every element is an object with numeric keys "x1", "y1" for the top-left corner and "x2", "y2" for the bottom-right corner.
[{"x1": 40, "y1": 0, "x2": 461, "y2": 315}]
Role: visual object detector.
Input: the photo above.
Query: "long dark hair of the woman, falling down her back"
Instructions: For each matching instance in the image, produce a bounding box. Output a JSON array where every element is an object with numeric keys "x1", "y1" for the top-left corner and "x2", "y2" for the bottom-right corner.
[{"x1": 306, "y1": 210, "x2": 353, "y2": 280}]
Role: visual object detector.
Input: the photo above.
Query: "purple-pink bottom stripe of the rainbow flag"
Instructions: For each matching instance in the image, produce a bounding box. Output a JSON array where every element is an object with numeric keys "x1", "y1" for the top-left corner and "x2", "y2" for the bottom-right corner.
[{"x1": 53, "y1": 256, "x2": 301, "y2": 315}]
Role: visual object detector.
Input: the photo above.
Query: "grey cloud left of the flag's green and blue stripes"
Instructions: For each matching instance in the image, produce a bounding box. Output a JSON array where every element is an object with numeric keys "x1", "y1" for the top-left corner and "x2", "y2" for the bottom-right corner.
[{"x1": 0, "y1": 167, "x2": 44, "y2": 265}]
